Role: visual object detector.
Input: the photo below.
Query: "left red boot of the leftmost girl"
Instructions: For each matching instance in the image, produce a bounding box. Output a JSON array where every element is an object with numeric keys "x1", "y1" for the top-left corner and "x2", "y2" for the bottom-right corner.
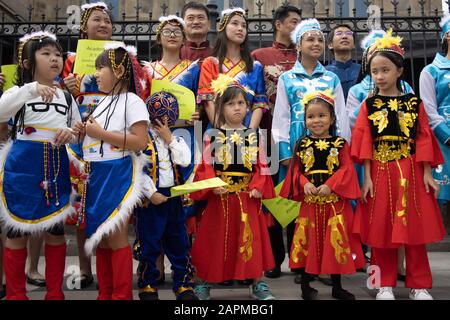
[{"x1": 3, "y1": 248, "x2": 28, "y2": 300}]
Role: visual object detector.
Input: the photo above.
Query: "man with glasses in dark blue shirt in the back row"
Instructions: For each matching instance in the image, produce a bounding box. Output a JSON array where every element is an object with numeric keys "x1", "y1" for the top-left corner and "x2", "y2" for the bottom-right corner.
[{"x1": 325, "y1": 24, "x2": 361, "y2": 100}]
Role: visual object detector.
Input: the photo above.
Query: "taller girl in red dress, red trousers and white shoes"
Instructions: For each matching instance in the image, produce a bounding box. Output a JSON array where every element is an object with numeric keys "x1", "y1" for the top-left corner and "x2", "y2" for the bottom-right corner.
[{"x1": 351, "y1": 30, "x2": 445, "y2": 300}]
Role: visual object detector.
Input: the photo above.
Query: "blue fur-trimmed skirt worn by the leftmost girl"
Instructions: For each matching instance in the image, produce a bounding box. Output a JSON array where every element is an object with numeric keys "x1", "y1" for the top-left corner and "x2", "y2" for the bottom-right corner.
[{"x1": 0, "y1": 140, "x2": 74, "y2": 232}]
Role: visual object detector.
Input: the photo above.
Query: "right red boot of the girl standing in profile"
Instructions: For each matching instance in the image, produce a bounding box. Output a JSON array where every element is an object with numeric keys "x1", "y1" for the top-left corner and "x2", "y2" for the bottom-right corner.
[{"x1": 111, "y1": 246, "x2": 133, "y2": 300}]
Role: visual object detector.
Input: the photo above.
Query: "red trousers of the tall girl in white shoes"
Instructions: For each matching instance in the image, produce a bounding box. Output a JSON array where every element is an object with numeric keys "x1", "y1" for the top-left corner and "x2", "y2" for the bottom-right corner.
[{"x1": 371, "y1": 245, "x2": 433, "y2": 289}]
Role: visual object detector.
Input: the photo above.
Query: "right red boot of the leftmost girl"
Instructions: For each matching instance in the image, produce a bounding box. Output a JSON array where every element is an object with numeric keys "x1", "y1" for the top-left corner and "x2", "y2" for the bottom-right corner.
[{"x1": 45, "y1": 243, "x2": 66, "y2": 300}]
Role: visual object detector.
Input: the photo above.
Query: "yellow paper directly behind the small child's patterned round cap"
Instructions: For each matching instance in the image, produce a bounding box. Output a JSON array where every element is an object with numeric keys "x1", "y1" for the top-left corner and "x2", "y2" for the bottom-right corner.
[{"x1": 150, "y1": 80, "x2": 195, "y2": 120}]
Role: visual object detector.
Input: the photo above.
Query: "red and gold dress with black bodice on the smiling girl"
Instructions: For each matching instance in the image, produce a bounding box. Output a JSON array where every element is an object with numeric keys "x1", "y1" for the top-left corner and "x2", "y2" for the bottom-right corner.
[{"x1": 280, "y1": 136, "x2": 365, "y2": 274}]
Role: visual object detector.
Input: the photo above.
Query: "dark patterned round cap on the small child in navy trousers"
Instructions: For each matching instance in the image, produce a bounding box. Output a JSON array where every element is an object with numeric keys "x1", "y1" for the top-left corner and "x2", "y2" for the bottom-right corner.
[{"x1": 146, "y1": 91, "x2": 179, "y2": 127}]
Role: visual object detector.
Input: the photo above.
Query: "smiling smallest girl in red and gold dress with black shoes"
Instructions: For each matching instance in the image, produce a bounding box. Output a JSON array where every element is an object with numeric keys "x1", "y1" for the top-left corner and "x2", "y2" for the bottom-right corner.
[{"x1": 280, "y1": 90, "x2": 365, "y2": 300}]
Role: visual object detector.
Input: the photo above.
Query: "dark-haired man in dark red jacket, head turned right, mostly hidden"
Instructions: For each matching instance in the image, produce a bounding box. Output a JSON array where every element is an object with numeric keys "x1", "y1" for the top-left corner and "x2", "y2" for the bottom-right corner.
[{"x1": 252, "y1": 5, "x2": 301, "y2": 278}]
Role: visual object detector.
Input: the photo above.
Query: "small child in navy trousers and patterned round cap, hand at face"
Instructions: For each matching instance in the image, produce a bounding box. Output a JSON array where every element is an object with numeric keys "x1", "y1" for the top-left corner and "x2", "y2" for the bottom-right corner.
[{"x1": 134, "y1": 92, "x2": 197, "y2": 300}]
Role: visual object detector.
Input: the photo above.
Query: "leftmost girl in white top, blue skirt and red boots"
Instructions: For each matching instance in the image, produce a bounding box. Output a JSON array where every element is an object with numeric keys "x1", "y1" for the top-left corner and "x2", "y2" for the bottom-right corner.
[{"x1": 0, "y1": 32, "x2": 81, "y2": 300}]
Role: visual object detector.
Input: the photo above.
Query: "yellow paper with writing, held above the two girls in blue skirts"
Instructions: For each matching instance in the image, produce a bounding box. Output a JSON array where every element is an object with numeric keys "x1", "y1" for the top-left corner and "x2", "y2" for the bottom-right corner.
[{"x1": 73, "y1": 40, "x2": 117, "y2": 75}]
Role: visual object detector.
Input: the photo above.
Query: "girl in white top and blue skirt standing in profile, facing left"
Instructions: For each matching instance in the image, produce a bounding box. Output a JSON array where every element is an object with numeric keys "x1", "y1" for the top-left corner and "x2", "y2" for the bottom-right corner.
[{"x1": 72, "y1": 43, "x2": 154, "y2": 300}]
